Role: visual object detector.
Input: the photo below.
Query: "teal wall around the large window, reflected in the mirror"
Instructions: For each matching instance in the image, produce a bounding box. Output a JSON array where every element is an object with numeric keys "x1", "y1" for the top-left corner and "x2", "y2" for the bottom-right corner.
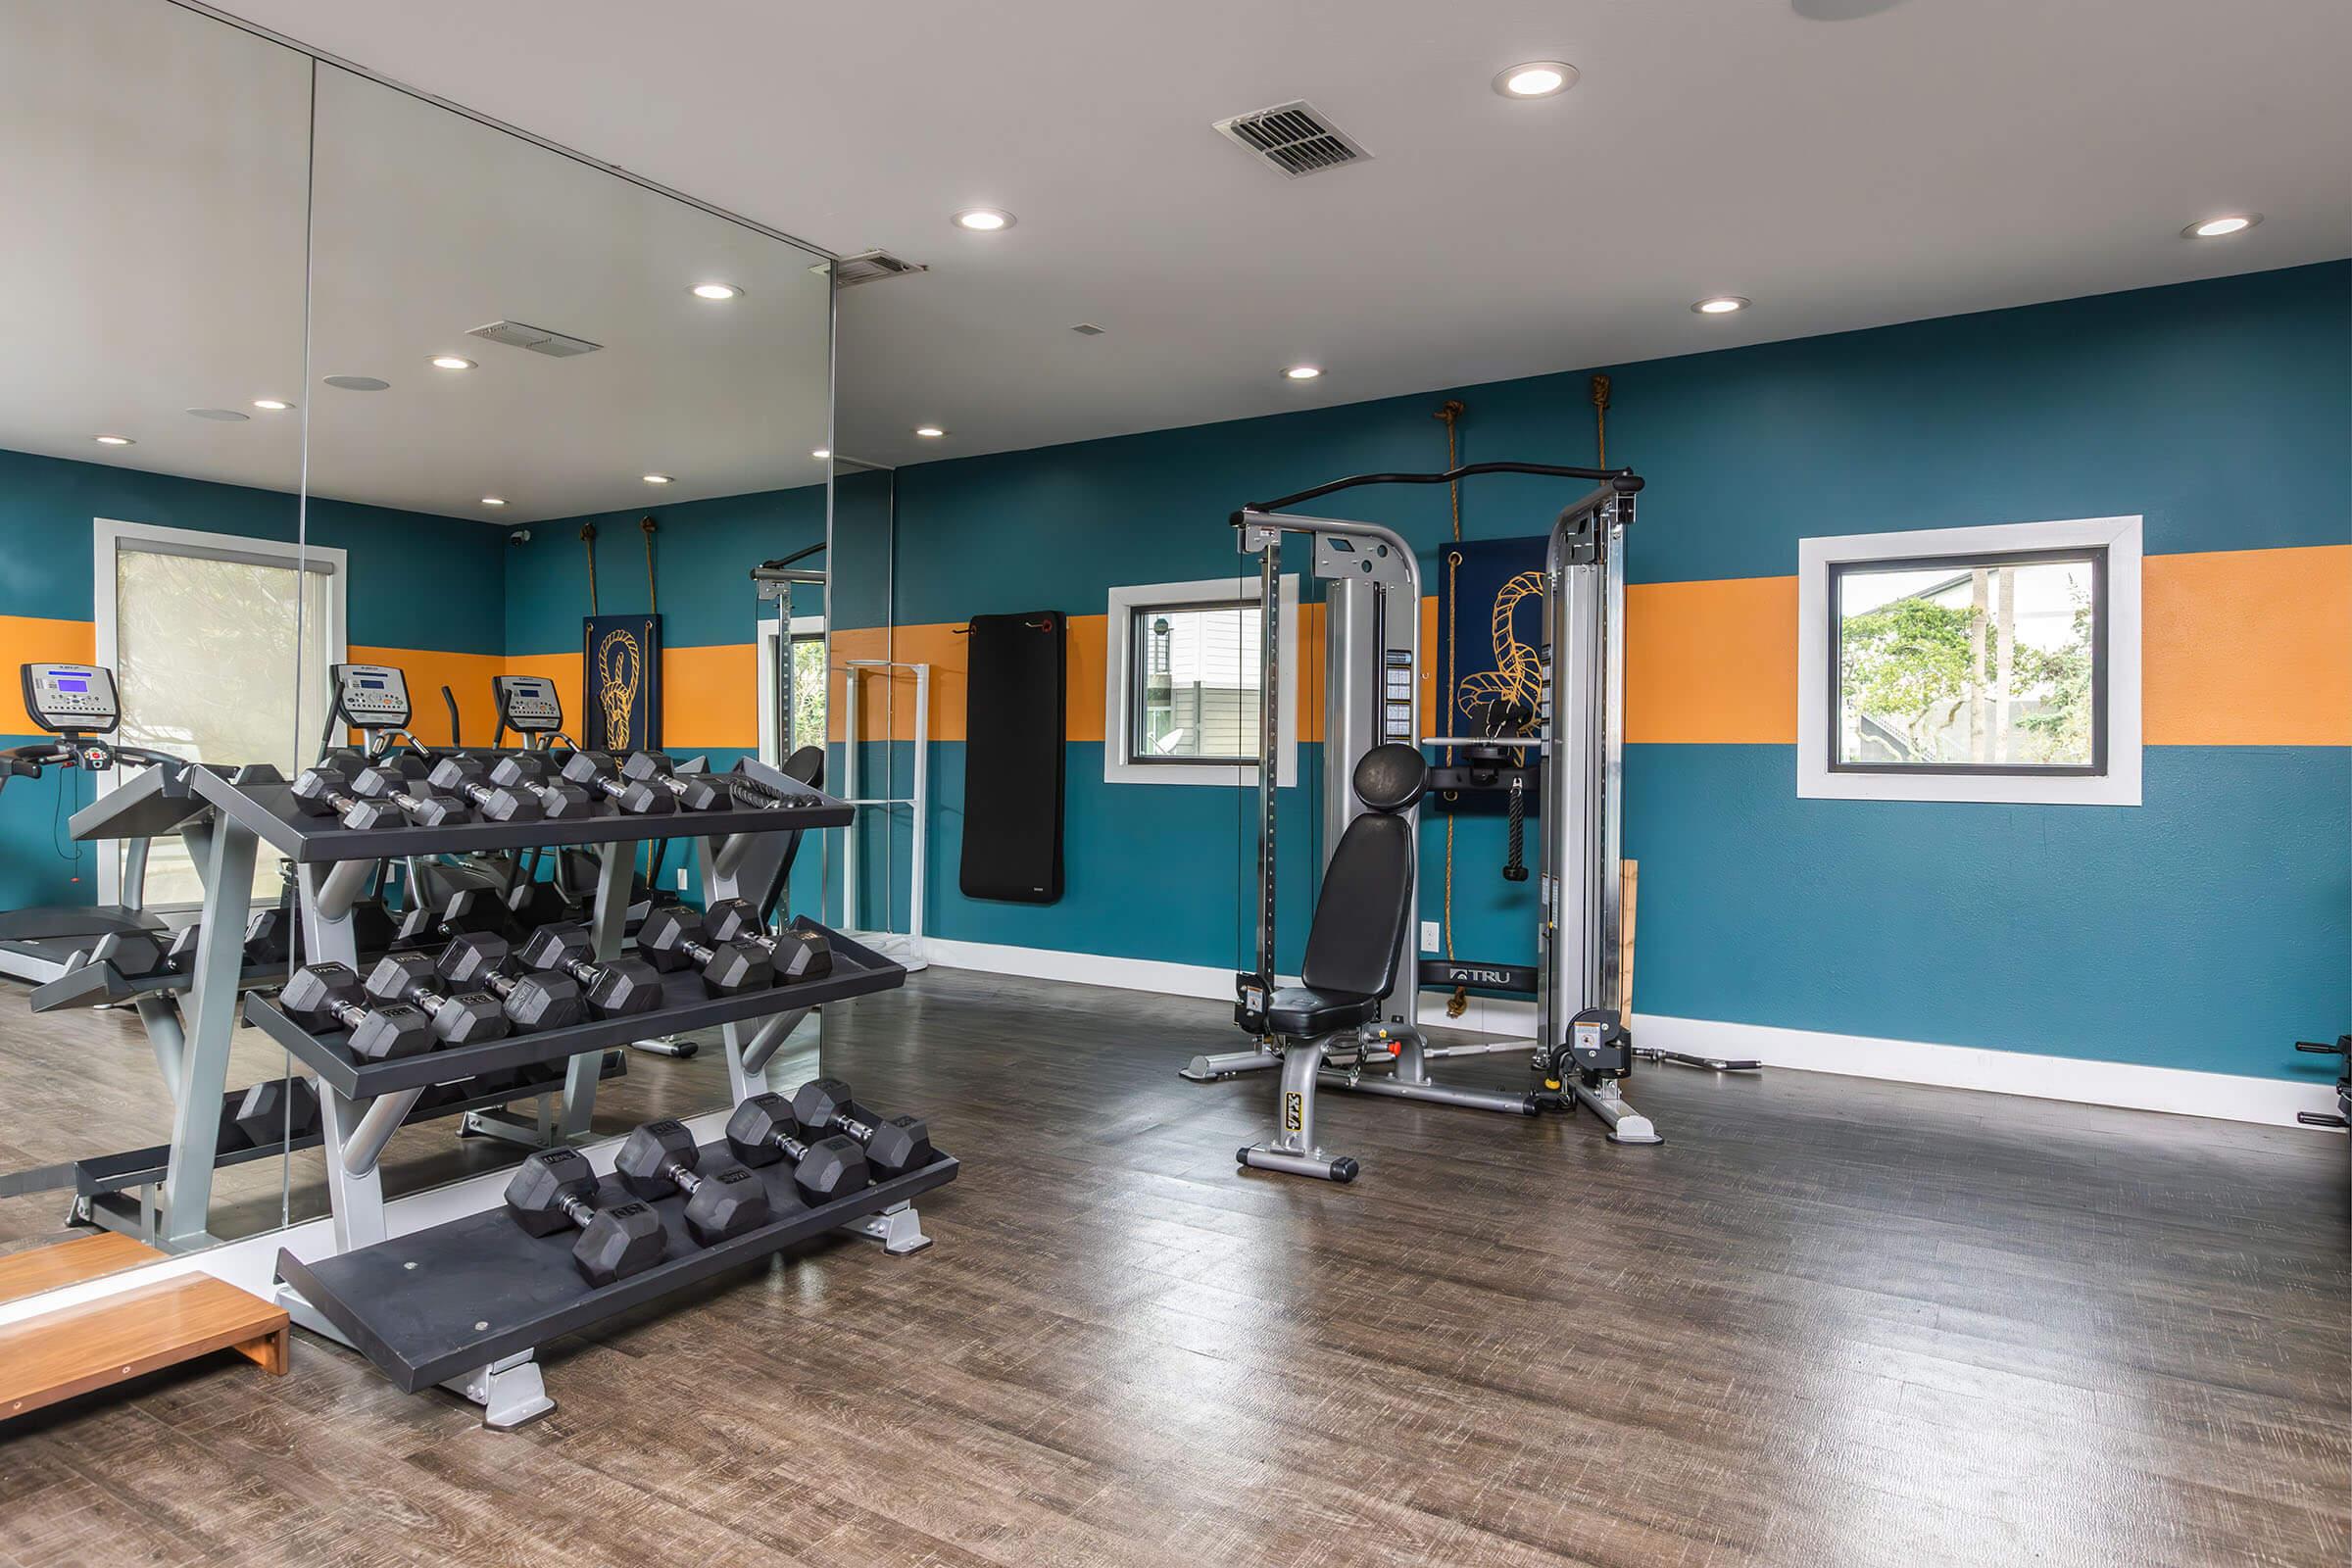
[{"x1": 0, "y1": 452, "x2": 506, "y2": 907}]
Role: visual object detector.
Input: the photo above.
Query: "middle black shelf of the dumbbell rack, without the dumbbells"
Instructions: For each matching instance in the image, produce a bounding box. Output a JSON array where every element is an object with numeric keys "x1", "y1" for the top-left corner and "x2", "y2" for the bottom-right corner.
[{"x1": 245, "y1": 919, "x2": 906, "y2": 1101}]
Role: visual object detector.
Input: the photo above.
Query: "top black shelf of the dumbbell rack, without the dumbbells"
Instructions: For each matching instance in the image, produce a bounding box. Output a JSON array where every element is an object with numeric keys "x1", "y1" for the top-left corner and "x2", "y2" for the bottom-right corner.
[{"x1": 190, "y1": 753, "x2": 854, "y2": 865}]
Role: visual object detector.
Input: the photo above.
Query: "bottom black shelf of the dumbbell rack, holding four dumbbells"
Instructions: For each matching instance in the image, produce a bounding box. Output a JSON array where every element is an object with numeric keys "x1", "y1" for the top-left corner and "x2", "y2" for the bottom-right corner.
[{"x1": 277, "y1": 1143, "x2": 957, "y2": 1394}]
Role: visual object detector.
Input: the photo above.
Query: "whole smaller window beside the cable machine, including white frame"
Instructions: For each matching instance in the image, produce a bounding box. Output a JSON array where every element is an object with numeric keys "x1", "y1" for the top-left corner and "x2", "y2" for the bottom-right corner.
[{"x1": 1103, "y1": 578, "x2": 1298, "y2": 785}]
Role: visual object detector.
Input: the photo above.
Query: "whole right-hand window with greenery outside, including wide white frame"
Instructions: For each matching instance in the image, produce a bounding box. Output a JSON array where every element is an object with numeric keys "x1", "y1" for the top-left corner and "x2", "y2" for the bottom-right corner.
[{"x1": 1797, "y1": 517, "x2": 2140, "y2": 807}]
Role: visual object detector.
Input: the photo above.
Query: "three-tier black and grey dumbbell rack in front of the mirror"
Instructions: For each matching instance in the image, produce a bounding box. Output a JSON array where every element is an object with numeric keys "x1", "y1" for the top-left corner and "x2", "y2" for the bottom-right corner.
[{"x1": 195, "y1": 760, "x2": 936, "y2": 1425}]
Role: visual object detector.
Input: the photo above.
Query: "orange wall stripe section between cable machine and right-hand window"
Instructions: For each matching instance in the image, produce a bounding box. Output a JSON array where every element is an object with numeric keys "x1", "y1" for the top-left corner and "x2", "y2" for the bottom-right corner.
[{"x1": 1625, "y1": 576, "x2": 1797, "y2": 745}]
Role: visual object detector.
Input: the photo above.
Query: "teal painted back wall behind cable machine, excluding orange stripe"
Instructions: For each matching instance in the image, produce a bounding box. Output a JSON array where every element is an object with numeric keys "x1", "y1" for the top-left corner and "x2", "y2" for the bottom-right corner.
[{"x1": 899, "y1": 264, "x2": 2352, "y2": 1077}]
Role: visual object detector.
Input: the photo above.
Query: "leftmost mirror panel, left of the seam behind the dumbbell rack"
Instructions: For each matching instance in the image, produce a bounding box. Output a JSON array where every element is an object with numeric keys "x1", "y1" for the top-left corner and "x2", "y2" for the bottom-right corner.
[{"x1": 0, "y1": 0, "x2": 315, "y2": 1250}]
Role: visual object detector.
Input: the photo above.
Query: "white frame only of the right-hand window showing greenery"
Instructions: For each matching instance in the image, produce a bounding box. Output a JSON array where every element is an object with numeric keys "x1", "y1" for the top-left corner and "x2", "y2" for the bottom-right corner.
[{"x1": 1797, "y1": 517, "x2": 2140, "y2": 807}]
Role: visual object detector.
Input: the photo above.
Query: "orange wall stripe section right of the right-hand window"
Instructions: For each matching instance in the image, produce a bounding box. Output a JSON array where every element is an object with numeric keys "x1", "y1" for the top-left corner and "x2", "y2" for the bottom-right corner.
[{"x1": 2140, "y1": 546, "x2": 2352, "y2": 745}]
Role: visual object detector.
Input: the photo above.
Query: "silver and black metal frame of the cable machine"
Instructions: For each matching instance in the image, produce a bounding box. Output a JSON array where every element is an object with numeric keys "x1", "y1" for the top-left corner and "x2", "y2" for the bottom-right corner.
[{"x1": 1183, "y1": 464, "x2": 1660, "y2": 1180}]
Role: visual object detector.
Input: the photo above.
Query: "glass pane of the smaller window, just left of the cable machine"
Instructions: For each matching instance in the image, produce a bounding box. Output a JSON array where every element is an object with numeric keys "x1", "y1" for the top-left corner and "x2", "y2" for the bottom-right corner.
[{"x1": 1129, "y1": 602, "x2": 1258, "y2": 766}]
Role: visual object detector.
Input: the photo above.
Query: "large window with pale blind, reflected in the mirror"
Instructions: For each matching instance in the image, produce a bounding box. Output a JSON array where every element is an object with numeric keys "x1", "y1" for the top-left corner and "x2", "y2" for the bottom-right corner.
[{"x1": 94, "y1": 519, "x2": 343, "y2": 909}]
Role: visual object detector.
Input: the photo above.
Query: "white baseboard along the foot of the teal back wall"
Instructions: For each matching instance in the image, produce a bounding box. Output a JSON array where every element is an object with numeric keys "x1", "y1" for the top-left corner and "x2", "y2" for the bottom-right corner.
[{"x1": 924, "y1": 936, "x2": 2335, "y2": 1126}]
